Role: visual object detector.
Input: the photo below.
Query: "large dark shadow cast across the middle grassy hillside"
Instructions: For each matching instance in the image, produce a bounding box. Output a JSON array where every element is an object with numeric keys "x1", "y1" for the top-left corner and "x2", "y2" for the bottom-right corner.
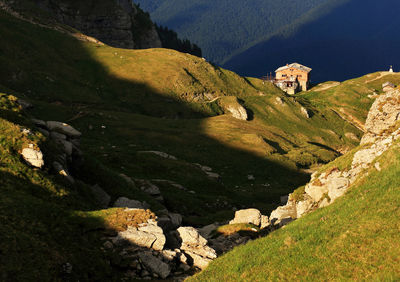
[{"x1": 0, "y1": 8, "x2": 308, "y2": 223}]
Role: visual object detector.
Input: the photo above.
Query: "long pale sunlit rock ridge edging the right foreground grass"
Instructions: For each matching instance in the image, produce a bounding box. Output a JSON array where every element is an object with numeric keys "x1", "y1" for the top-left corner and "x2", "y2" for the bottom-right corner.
[{"x1": 270, "y1": 90, "x2": 400, "y2": 226}]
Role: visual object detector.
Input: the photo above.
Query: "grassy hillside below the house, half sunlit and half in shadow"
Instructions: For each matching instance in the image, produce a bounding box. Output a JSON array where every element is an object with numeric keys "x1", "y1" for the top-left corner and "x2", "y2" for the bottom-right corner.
[{"x1": 0, "y1": 8, "x2": 361, "y2": 223}]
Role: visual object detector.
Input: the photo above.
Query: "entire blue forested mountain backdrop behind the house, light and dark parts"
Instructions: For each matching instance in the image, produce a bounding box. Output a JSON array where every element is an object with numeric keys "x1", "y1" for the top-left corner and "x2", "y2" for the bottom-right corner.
[{"x1": 138, "y1": 0, "x2": 400, "y2": 82}]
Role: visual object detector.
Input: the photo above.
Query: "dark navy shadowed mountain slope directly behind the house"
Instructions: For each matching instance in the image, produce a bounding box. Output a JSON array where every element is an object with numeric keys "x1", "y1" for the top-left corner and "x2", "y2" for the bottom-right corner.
[{"x1": 223, "y1": 0, "x2": 400, "y2": 82}]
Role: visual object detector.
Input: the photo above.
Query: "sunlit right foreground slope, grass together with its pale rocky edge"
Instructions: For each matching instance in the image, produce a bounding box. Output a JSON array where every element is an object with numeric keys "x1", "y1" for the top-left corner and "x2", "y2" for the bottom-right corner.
[{"x1": 189, "y1": 90, "x2": 400, "y2": 281}]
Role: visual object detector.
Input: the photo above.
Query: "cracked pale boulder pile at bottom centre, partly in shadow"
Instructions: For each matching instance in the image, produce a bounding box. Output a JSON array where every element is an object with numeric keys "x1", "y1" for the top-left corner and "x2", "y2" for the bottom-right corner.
[{"x1": 103, "y1": 209, "x2": 217, "y2": 280}]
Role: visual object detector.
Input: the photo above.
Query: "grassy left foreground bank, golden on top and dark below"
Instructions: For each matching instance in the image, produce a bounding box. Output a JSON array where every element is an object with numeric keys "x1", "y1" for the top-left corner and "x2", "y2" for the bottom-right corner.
[{"x1": 0, "y1": 94, "x2": 136, "y2": 281}]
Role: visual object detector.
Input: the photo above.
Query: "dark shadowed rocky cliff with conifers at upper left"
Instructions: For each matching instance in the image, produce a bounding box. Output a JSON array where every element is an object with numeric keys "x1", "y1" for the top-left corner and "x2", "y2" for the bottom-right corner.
[{"x1": 9, "y1": 0, "x2": 161, "y2": 49}]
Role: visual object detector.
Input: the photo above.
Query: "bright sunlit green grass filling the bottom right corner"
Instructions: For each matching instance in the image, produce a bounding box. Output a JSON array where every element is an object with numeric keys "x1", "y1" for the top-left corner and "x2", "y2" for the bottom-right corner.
[{"x1": 189, "y1": 139, "x2": 400, "y2": 281}]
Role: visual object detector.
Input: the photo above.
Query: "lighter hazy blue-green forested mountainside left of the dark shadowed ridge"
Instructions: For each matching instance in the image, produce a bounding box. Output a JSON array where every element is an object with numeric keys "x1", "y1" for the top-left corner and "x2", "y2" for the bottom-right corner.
[{"x1": 135, "y1": 0, "x2": 346, "y2": 63}]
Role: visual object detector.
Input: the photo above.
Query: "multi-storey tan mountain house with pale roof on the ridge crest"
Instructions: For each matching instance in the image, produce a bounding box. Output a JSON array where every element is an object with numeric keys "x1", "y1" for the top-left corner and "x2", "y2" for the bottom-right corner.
[{"x1": 274, "y1": 63, "x2": 312, "y2": 95}]
